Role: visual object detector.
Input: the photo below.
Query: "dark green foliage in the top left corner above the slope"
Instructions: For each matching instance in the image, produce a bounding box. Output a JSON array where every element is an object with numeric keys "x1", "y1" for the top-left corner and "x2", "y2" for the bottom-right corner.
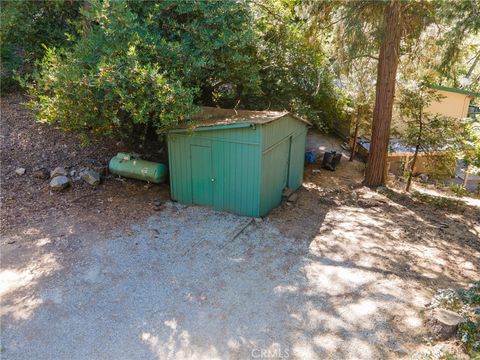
[{"x1": 0, "y1": 0, "x2": 82, "y2": 93}]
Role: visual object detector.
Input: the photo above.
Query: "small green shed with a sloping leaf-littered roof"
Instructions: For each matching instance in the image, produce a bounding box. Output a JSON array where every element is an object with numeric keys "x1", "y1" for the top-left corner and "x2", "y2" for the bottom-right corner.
[{"x1": 168, "y1": 107, "x2": 311, "y2": 217}]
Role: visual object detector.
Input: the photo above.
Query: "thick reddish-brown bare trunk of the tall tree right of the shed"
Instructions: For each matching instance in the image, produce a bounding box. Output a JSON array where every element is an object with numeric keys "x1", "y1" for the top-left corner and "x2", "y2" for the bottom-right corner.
[{"x1": 364, "y1": 0, "x2": 402, "y2": 187}]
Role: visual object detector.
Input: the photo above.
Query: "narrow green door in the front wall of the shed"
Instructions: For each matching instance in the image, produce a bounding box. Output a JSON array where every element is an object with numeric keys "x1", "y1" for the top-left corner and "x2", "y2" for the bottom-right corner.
[{"x1": 190, "y1": 145, "x2": 215, "y2": 206}]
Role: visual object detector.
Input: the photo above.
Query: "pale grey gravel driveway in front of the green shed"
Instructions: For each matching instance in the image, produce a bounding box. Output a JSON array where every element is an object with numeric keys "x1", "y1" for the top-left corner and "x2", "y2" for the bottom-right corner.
[{"x1": 1, "y1": 194, "x2": 475, "y2": 360}]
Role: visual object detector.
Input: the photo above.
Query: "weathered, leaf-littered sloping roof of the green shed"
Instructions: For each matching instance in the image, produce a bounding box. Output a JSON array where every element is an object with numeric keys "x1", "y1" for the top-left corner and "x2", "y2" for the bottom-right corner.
[{"x1": 179, "y1": 106, "x2": 312, "y2": 129}]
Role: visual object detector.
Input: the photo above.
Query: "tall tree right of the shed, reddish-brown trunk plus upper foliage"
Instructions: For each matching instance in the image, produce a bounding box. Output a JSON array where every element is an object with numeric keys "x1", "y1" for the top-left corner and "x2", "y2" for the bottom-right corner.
[{"x1": 303, "y1": 0, "x2": 480, "y2": 186}]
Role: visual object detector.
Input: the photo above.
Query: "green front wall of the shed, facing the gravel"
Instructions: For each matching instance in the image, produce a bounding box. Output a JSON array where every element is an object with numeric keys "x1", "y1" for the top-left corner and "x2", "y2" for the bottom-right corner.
[{"x1": 168, "y1": 127, "x2": 261, "y2": 216}]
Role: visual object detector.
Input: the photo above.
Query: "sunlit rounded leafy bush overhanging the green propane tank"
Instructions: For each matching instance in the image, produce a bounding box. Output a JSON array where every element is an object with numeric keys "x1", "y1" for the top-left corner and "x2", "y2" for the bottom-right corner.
[{"x1": 30, "y1": 1, "x2": 205, "y2": 140}]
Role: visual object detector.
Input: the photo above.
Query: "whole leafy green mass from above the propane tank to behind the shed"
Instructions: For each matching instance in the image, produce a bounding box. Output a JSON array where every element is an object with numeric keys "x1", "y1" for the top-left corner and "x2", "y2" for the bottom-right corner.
[{"x1": 25, "y1": 1, "x2": 256, "y2": 139}]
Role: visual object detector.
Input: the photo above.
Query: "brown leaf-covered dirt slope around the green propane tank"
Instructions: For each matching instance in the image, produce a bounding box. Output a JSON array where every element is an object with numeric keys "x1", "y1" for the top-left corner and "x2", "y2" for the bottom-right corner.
[{"x1": 0, "y1": 94, "x2": 169, "y2": 236}]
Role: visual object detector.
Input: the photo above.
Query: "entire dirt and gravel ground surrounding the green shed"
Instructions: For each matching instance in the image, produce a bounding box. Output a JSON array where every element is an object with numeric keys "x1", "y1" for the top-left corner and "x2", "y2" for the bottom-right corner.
[{"x1": 0, "y1": 97, "x2": 480, "y2": 359}]
